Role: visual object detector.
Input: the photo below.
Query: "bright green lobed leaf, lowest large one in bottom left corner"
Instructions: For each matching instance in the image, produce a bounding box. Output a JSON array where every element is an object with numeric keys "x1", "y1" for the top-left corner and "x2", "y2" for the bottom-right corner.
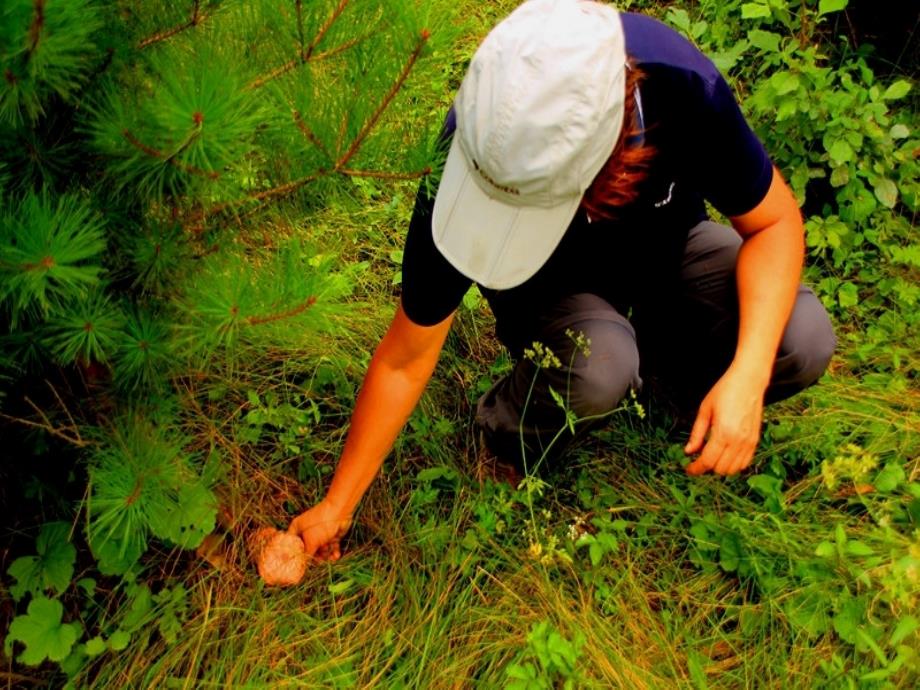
[{"x1": 8, "y1": 596, "x2": 81, "y2": 666}]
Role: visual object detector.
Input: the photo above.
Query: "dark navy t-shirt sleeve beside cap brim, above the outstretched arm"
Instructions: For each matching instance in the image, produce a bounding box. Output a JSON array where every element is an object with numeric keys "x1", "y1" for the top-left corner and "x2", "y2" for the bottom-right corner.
[{"x1": 402, "y1": 111, "x2": 473, "y2": 326}]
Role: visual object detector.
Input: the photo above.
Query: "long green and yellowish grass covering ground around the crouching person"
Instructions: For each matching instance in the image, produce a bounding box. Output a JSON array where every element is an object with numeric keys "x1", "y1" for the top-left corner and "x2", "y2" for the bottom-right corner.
[{"x1": 76, "y1": 179, "x2": 920, "y2": 688}]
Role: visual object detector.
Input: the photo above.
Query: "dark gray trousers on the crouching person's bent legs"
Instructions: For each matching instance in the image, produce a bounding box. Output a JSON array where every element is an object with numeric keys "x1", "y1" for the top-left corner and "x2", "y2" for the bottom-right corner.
[{"x1": 476, "y1": 221, "x2": 836, "y2": 468}]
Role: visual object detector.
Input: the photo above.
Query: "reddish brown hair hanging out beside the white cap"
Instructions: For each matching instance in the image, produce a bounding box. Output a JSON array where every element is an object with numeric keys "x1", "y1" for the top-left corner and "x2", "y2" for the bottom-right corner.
[{"x1": 581, "y1": 65, "x2": 655, "y2": 219}]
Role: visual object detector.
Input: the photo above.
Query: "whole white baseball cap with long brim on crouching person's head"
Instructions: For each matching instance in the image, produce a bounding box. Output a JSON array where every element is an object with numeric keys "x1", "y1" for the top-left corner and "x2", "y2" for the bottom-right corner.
[{"x1": 432, "y1": 0, "x2": 626, "y2": 289}]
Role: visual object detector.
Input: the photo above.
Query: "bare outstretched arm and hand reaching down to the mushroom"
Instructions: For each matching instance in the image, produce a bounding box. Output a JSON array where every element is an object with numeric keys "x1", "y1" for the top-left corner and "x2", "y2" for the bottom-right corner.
[{"x1": 288, "y1": 306, "x2": 453, "y2": 560}]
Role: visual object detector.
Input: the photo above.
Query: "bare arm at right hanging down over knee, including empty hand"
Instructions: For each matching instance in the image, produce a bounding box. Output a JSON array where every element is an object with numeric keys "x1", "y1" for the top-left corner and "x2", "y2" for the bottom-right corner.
[{"x1": 684, "y1": 170, "x2": 805, "y2": 474}]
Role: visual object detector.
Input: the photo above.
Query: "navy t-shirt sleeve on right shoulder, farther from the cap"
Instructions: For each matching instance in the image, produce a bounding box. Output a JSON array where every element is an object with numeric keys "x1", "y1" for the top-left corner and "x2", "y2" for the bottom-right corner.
[{"x1": 686, "y1": 66, "x2": 773, "y2": 216}]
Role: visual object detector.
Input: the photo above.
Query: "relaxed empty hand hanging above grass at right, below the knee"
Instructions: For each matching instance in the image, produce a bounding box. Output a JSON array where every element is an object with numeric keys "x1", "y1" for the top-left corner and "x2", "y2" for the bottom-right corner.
[{"x1": 684, "y1": 370, "x2": 764, "y2": 475}]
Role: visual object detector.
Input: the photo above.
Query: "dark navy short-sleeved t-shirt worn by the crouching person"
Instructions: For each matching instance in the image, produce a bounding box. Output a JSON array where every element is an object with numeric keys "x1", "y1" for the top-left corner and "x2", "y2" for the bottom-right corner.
[{"x1": 402, "y1": 13, "x2": 772, "y2": 354}]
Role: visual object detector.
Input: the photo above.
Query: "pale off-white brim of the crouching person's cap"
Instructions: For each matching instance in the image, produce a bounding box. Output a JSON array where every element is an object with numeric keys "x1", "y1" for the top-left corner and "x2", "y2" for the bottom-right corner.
[{"x1": 432, "y1": 135, "x2": 581, "y2": 290}]
